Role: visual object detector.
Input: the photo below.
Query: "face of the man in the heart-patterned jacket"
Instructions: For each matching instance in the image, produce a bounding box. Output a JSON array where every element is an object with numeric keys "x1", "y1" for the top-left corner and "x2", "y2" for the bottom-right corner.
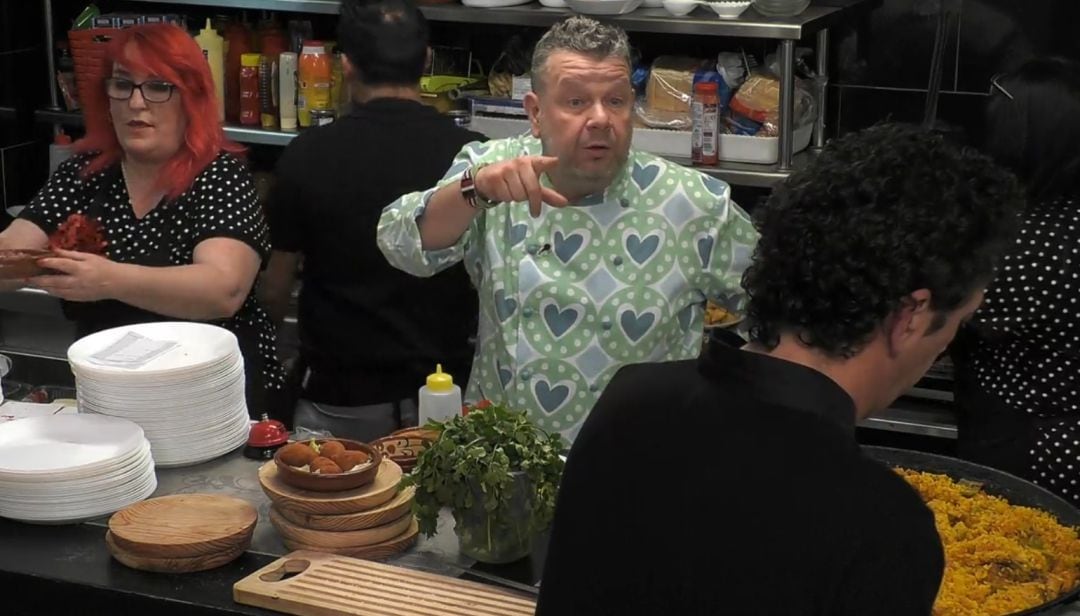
[{"x1": 525, "y1": 52, "x2": 634, "y2": 191}]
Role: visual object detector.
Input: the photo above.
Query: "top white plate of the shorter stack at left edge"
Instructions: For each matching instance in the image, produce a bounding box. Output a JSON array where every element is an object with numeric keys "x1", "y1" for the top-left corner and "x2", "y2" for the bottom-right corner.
[{"x1": 0, "y1": 414, "x2": 143, "y2": 473}]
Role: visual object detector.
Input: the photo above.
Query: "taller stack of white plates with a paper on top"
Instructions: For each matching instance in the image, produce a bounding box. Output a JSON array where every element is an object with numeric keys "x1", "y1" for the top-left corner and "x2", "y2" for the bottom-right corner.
[{"x1": 68, "y1": 322, "x2": 251, "y2": 467}]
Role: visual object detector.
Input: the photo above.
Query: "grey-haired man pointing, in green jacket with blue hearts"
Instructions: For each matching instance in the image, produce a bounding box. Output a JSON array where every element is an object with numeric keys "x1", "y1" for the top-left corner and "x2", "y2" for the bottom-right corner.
[{"x1": 378, "y1": 16, "x2": 757, "y2": 440}]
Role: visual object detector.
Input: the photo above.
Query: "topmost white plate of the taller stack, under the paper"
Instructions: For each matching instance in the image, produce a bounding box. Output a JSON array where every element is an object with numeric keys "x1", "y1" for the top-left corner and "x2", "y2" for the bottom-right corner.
[{"x1": 68, "y1": 321, "x2": 239, "y2": 378}]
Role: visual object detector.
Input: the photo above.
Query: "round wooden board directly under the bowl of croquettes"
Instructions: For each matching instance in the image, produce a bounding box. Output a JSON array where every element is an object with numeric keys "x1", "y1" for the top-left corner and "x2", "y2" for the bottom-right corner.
[{"x1": 259, "y1": 459, "x2": 402, "y2": 515}]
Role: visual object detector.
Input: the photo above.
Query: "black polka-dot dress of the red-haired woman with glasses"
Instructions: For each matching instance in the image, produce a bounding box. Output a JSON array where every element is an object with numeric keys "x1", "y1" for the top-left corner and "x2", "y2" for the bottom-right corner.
[{"x1": 21, "y1": 152, "x2": 284, "y2": 417}]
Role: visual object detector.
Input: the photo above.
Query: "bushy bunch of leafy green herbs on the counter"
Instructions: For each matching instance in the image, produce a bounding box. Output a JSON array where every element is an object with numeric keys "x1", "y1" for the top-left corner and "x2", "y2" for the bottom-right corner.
[{"x1": 405, "y1": 401, "x2": 565, "y2": 548}]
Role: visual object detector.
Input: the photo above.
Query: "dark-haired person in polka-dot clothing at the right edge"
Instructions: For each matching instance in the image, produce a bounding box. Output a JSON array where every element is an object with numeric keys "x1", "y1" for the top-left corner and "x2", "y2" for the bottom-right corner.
[{"x1": 954, "y1": 58, "x2": 1080, "y2": 505}]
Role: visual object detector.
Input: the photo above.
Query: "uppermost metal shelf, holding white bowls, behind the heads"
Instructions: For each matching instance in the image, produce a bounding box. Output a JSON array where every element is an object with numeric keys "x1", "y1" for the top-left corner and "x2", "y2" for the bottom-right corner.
[{"x1": 120, "y1": 0, "x2": 843, "y2": 41}]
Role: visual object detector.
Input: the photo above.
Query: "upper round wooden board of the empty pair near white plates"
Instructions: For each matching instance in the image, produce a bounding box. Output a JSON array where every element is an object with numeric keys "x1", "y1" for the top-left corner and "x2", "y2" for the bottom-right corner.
[{"x1": 109, "y1": 494, "x2": 259, "y2": 559}]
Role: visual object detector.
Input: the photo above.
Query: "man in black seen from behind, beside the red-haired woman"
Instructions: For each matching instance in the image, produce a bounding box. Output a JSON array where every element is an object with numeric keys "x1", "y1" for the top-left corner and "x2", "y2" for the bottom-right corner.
[{"x1": 264, "y1": 0, "x2": 484, "y2": 441}]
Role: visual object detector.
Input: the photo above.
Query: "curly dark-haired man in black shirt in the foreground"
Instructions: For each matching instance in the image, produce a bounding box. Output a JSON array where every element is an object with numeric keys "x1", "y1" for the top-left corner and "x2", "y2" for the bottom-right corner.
[{"x1": 537, "y1": 125, "x2": 1023, "y2": 616}]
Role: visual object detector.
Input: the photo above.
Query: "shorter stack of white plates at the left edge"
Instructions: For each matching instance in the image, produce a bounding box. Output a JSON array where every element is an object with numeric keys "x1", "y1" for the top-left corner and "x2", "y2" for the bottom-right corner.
[{"x1": 0, "y1": 415, "x2": 158, "y2": 524}]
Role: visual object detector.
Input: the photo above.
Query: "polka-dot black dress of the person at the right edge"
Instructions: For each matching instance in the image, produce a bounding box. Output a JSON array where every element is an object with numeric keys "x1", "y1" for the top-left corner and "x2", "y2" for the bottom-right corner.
[{"x1": 961, "y1": 200, "x2": 1080, "y2": 504}]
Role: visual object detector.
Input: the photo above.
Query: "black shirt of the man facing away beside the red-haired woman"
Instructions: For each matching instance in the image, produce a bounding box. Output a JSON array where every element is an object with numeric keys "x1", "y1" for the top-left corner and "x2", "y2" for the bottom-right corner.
[{"x1": 269, "y1": 98, "x2": 484, "y2": 405}]
